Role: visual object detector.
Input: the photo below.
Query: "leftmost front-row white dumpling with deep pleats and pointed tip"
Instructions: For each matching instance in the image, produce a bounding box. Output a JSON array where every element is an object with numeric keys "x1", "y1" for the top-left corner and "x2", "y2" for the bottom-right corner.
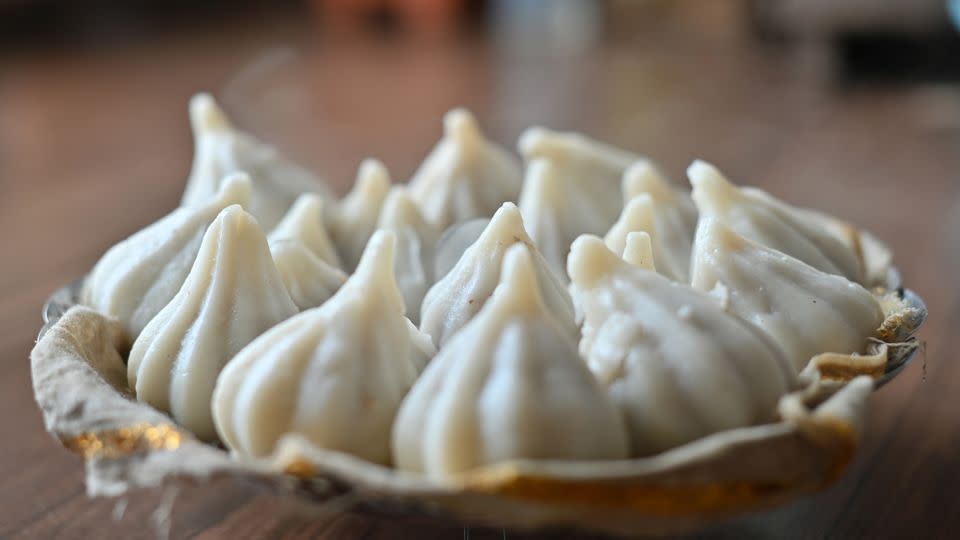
[{"x1": 127, "y1": 205, "x2": 299, "y2": 441}]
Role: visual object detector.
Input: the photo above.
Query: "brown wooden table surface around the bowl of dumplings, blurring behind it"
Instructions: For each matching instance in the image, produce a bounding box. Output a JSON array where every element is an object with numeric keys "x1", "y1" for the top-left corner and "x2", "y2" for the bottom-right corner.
[{"x1": 0, "y1": 12, "x2": 960, "y2": 539}]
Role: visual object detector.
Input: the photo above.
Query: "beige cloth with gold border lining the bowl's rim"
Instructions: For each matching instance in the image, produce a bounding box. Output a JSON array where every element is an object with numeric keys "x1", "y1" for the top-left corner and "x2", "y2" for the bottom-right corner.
[{"x1": 31, "y1": 272, "x2": 927, "y2": 534}]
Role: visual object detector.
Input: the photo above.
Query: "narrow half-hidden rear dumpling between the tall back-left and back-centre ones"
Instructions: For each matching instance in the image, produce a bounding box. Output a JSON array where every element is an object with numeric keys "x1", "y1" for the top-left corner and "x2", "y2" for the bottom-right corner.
[{"x1": 324, "y1": 159, "x2": 390, "y2": 272}]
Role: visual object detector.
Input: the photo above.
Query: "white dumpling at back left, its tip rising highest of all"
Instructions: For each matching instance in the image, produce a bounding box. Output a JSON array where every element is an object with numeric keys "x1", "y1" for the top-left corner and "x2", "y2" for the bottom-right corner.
[{"x1": 182, "y1": 94, "x2": 328, "y2": 230}]
